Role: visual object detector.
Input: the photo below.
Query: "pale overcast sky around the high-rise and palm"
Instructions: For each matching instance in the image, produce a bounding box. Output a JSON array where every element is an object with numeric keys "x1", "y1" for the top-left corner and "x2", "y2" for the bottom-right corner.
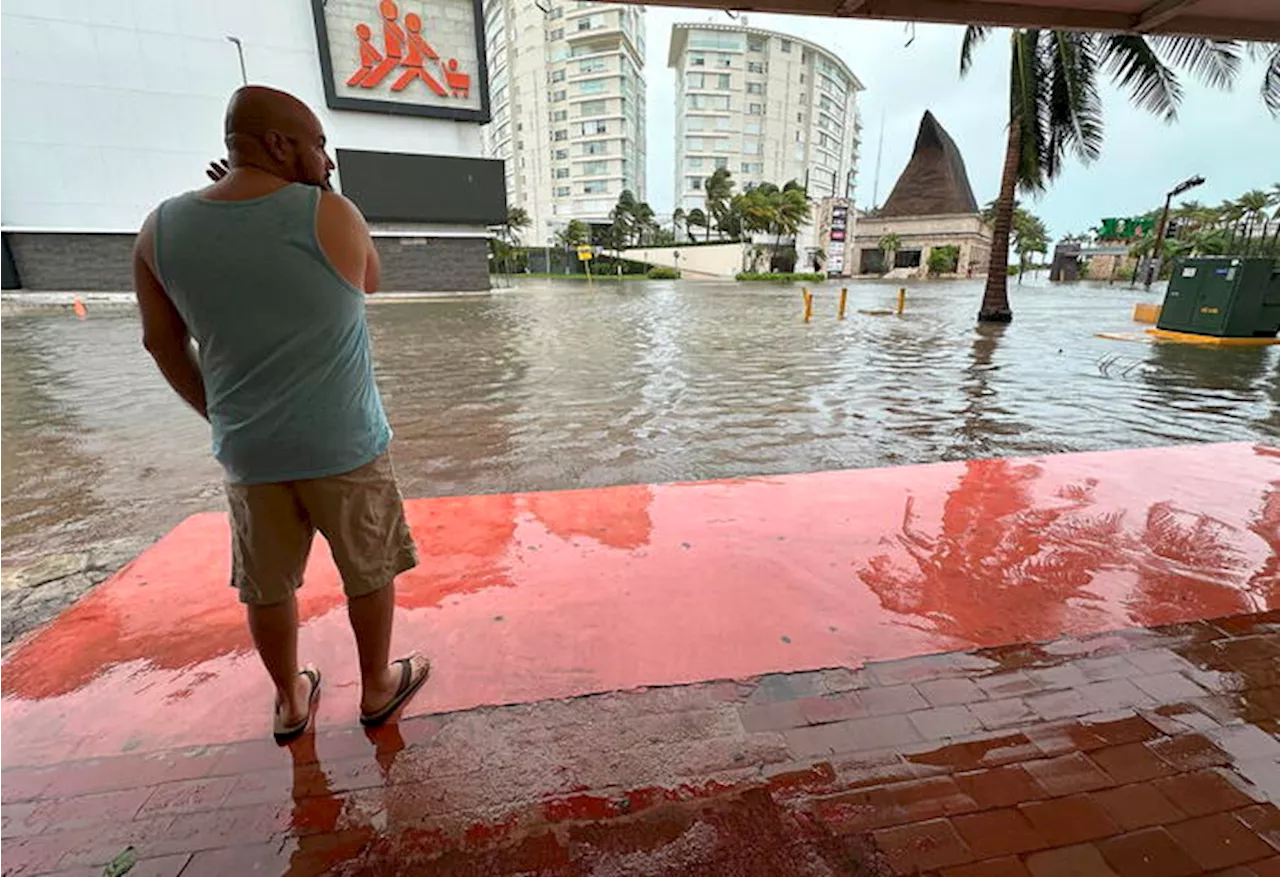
[{"x1": 645, "y1": 6, "x2": 1280, "y2": 237}]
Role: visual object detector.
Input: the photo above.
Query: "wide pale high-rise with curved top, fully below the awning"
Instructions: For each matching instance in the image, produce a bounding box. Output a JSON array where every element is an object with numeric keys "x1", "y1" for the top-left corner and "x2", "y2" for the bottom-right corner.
[{"x1": 667, "y1": 24, "x2": 863, "y2": 210}]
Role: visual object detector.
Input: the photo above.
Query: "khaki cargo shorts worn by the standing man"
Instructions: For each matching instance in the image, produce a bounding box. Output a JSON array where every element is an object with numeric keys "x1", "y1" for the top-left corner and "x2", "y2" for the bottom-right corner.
[{"x1": 227, "y1": 453, "x2": 417, "y2": 606}]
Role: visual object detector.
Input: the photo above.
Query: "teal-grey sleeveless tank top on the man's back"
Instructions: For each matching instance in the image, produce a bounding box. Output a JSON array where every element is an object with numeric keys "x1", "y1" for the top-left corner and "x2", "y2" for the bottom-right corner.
[{"x1": 155, "y1": 183, "x2": 392, "y2": 484}]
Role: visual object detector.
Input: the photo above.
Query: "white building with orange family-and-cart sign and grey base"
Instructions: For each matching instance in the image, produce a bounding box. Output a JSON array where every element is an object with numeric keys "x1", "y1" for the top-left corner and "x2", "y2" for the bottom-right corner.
[{"x1": 0, "y1": 0, "x2": 506, "y2": 289}]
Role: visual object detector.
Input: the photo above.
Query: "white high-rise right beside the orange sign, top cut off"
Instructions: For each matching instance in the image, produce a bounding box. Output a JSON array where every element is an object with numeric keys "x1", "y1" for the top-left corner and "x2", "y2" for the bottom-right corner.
[{"x1": 484, "y1": 0, "x2": 645, "y2": 245}]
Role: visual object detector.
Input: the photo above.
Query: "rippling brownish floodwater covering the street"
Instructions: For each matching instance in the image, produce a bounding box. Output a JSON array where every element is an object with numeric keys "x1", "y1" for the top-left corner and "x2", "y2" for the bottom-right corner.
[{"x1": 0, "y1": 273, "x2": 1280, "y2": 566}]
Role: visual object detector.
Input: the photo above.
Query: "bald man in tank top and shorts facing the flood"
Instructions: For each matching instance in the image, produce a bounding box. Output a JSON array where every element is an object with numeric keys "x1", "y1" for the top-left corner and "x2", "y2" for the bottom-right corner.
[{"x1": 133, "y1": 86, "x2": 430, "y2": 743}]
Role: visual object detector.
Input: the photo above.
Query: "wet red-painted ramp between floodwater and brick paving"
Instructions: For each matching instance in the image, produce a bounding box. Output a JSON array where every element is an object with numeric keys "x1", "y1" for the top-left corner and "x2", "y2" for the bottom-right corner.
[{"x1": 0, "y1": 444, "x2": 1280, "y2": 766}]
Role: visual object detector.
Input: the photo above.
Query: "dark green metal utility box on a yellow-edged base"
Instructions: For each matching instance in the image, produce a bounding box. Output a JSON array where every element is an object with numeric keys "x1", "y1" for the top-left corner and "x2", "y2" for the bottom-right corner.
[{"x1": 1158, "y1": 256, "x2": 1280, "y2": 338}]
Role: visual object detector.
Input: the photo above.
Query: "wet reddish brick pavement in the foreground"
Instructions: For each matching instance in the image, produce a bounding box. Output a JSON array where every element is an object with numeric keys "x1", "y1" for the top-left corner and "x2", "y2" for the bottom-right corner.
[{"x1": 0, "y1": 613, "x2": 1280, "y2": 877}]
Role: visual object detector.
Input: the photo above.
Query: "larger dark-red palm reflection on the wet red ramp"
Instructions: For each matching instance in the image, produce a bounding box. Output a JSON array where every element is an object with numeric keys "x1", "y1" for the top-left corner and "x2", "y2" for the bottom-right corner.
[{"x1": 859, "y1": 460, "x2": 1123, "y2": 641}]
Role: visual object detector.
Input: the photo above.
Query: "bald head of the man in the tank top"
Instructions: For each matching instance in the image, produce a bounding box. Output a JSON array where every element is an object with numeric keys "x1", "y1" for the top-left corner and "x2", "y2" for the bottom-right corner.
[{"x1": 224, "y1": 86, "x2": 333, "y2": 187}]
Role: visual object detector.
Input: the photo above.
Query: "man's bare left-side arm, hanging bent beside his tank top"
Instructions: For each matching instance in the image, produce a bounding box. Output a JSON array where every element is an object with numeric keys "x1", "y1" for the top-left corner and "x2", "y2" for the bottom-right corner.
[{"x1": 133, "y1": 214, "x2": 209, "y2": 420}]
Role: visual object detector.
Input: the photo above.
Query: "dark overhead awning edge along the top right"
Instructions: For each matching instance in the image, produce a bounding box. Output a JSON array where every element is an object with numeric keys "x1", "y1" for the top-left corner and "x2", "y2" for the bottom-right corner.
[{"x1": 645, "y1": 0, "x2": 1280, "y2": 42}]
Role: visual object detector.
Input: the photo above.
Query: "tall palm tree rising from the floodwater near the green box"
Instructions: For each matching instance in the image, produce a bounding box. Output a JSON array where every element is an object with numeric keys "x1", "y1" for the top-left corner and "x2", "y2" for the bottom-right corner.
[{"x1": 960, "y1": 26, "x2": 1240, "y2": 323}]
